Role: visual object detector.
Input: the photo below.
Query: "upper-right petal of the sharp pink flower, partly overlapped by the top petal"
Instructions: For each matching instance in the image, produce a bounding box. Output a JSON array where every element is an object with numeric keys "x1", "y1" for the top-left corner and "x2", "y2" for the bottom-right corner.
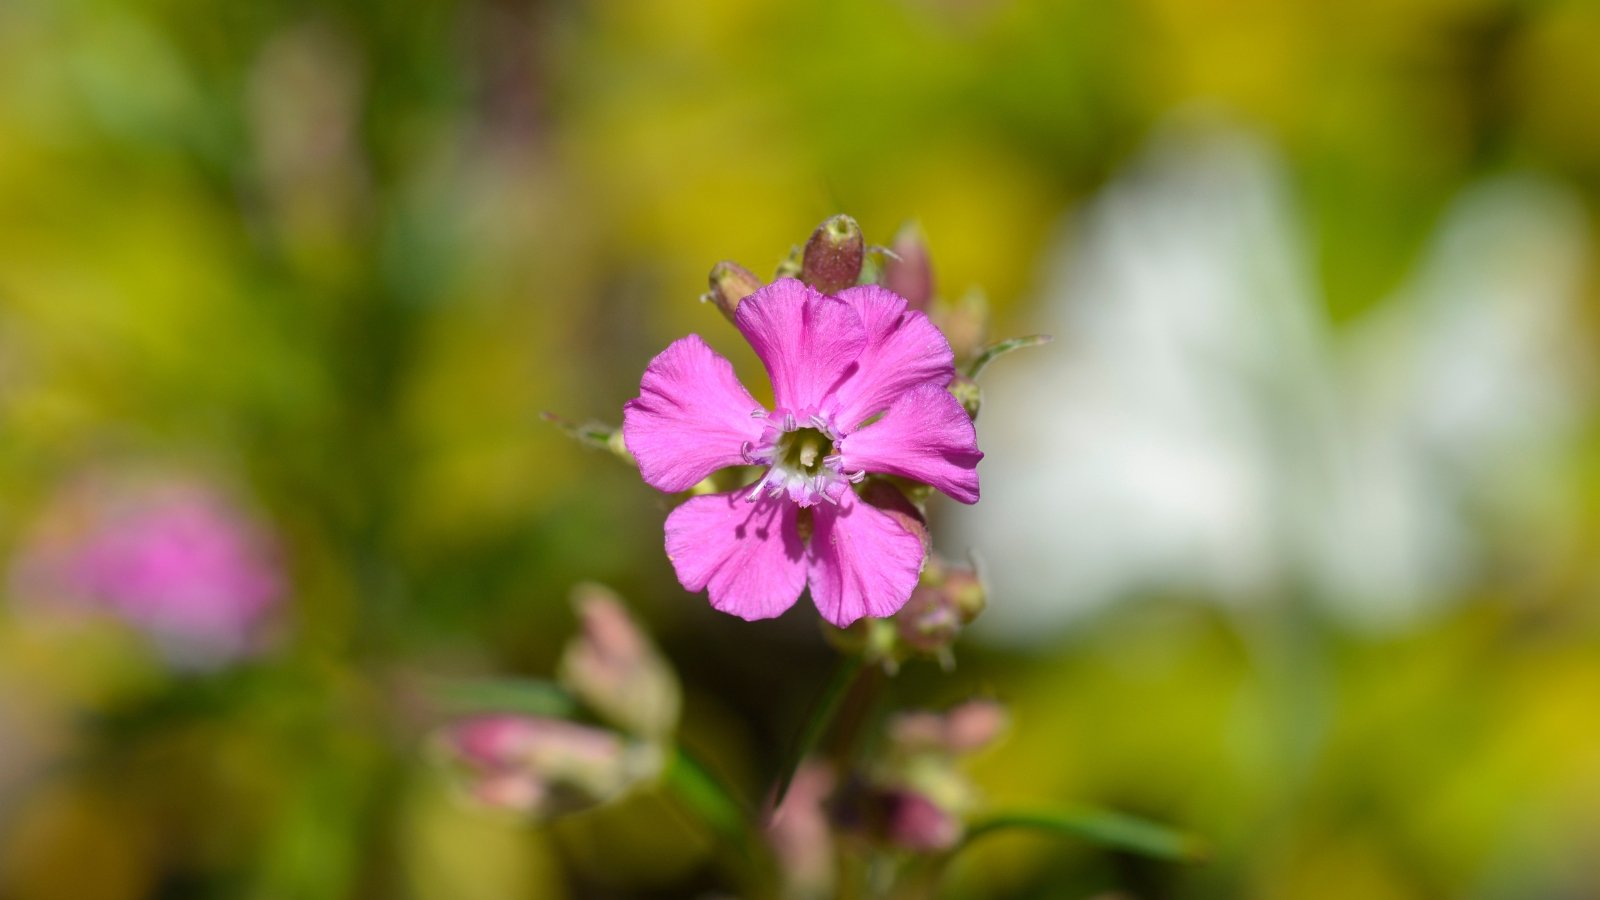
[{"x1": 834, "y1": 285, "x2": 955, "y2": 434}]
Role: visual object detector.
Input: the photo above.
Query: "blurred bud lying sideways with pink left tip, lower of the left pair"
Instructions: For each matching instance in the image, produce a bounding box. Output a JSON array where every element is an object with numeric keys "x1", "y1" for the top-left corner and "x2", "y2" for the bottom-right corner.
[{"x1": 438, "y1": 716, "x2": 661, "y2": 818}]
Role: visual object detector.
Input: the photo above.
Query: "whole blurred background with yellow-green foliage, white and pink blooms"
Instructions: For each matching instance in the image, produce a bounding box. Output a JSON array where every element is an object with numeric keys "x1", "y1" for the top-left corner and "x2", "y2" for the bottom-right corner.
[{"x1": 0, "y1": 0, "x2": 1600, "y2": 900}]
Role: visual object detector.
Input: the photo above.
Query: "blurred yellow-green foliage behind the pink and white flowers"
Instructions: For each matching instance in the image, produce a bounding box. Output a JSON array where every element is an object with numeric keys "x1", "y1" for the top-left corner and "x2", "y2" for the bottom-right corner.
[{"x1": 0, "y1": 0, "x2": 1600, "y2": 900}]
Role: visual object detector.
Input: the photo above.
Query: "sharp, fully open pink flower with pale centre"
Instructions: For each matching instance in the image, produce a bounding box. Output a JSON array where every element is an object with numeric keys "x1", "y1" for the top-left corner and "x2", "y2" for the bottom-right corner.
[{"x1": 622, "y1": 279, "x2": 982, "y2": 626}]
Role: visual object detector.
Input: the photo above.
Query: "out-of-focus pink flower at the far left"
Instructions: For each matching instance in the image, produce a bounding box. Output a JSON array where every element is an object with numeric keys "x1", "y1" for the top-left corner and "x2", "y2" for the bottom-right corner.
[{"x1": 11, "y1": 479, "x2": 283, "y2": 666}]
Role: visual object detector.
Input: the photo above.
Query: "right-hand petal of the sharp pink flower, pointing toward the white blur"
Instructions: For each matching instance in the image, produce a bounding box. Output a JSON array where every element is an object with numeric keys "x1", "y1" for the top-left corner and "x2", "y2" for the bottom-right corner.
[{"x1": 838, "y1": 384, "x2": 984, "y2": 503}]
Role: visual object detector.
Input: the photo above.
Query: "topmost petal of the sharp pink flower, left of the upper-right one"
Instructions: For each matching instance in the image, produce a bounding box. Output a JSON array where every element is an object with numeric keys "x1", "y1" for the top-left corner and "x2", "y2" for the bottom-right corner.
[{"x1": 734, "y1": 279, "x2": 867, "y2": 413}]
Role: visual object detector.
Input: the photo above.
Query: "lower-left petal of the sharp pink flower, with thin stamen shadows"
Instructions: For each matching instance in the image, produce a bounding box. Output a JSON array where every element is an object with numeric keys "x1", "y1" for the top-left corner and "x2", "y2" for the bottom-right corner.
[{"x1": 667, "y1": 490, "x2": 805, "y2": 620}]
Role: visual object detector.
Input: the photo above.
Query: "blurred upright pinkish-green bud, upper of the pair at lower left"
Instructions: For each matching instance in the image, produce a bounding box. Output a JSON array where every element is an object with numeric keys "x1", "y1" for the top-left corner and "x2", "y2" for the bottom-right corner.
[{"x1": 560, "y1": 585, "x2": 683, "y2": 738}]
